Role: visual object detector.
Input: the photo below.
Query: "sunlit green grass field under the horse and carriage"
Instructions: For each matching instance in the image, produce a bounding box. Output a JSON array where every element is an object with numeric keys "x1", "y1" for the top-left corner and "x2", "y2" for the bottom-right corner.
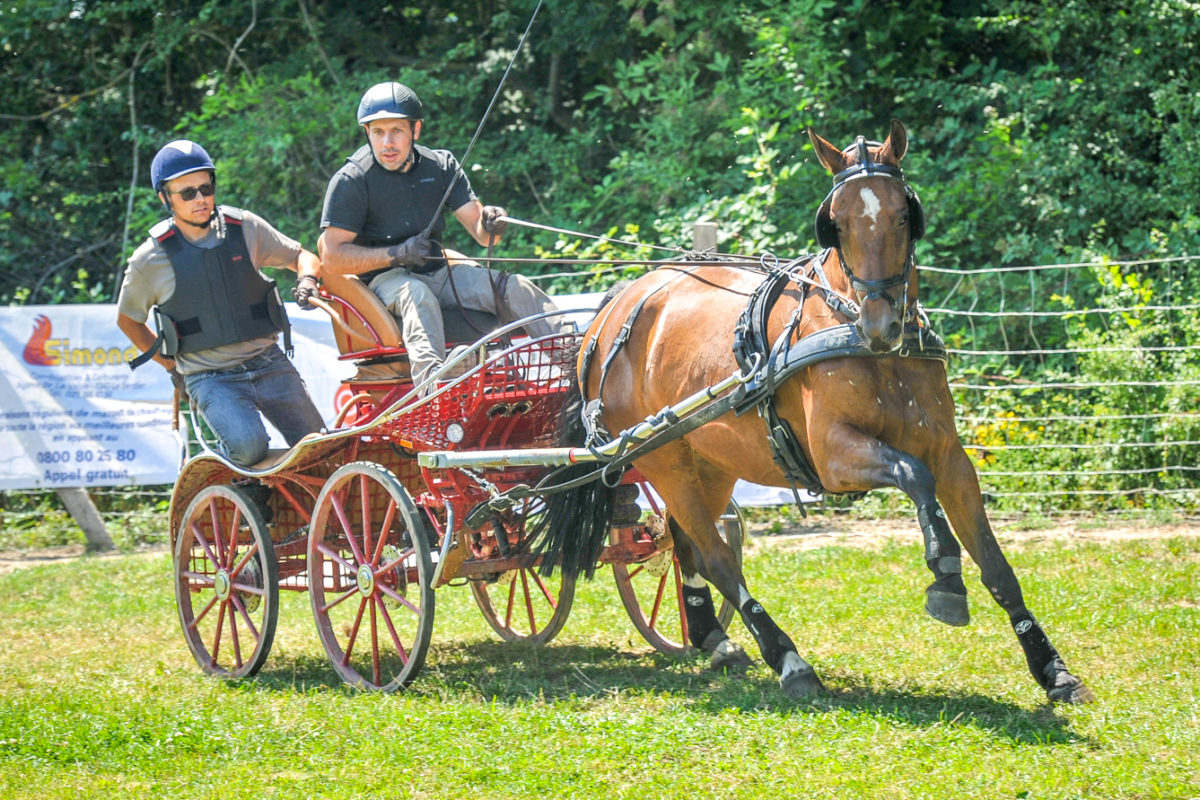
[{"x1": 0, "y1": 525, "x2": 1200, "y2": 800}]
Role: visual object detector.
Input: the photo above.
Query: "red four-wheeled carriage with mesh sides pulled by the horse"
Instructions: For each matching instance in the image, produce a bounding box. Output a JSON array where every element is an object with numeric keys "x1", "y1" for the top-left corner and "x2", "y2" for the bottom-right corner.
[{"x1": 170, "y1": 257, "x2": 744, "y2": 691}]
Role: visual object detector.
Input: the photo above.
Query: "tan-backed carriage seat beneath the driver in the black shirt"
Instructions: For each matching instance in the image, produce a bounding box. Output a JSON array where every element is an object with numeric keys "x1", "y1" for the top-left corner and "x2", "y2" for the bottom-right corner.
[{"x1": 320, "y1": 249, "x2": 500, "y2": 383}]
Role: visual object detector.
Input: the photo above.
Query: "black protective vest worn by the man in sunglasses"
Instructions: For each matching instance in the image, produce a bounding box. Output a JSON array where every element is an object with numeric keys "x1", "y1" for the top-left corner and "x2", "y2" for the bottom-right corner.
[{"x1": 130, "y1": 206, "x2": 292, "y2": 368}]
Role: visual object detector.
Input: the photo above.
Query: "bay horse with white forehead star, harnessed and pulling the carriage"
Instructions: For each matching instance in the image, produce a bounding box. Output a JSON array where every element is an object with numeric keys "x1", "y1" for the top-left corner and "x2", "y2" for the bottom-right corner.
[{"x1": 551, "y1": 121, "x2": 1093, "y2": 703}]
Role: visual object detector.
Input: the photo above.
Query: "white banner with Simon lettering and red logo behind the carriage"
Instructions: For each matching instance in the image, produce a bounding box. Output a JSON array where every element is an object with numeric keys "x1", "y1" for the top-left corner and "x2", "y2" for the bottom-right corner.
[{"x1": 0, "y1": 299, "x2": 815, "y2": 506}]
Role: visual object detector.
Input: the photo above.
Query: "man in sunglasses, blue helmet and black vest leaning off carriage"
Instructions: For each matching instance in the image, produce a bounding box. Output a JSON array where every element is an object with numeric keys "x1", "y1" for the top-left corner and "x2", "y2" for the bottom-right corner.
[{"x1": 116, "y1": 139, "x2": 324, "y2": 467}]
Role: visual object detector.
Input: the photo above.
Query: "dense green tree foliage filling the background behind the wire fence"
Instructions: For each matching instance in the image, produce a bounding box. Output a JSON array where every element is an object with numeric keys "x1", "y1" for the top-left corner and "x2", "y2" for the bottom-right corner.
[{"x1": 0, "y1": 0, "x2": 1200, "y2": 506}]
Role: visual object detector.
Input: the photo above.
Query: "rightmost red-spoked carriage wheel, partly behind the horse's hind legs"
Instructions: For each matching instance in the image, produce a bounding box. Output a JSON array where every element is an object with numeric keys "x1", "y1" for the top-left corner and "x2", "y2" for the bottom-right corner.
[{"x1": 612, "y1": 501, "x2": 745, "y2": 655}]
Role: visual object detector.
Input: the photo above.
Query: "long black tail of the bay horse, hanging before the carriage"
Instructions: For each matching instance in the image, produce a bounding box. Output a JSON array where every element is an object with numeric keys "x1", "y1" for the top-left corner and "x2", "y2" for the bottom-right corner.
[{"x1": 532, "y1": 335, "x2": 616, "y2": 578}]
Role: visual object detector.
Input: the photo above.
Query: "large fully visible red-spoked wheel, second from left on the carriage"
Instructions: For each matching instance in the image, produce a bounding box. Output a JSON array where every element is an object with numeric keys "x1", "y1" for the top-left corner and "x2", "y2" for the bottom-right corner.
[{"x1": 308, "y1": 462, "x2": 433, "y2": 692}]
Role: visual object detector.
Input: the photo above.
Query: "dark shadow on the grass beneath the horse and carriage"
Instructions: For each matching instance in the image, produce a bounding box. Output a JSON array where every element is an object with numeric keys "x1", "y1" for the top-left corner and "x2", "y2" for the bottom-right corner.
[{"x1": 248, "y1": 640, "x2": 1086, "y2": 745}]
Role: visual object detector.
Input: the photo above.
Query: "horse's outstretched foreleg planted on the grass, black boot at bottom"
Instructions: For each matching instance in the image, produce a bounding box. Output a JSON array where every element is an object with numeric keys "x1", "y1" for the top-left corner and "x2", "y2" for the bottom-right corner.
[{"x1": 942, "y1": 453, "x2": 1096, "y2": 703}]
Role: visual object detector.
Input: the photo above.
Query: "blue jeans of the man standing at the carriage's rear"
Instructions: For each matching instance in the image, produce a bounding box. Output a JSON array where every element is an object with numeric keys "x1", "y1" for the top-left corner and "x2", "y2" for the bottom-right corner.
[{"x1": 185, "y1": 345, "x2": 325, "y2": 467}]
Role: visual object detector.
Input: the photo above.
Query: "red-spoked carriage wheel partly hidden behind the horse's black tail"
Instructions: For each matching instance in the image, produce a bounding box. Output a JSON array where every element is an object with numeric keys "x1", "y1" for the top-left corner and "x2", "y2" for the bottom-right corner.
[{"x1": 470, "y1": 497, "x2": 575, "y2": 644}]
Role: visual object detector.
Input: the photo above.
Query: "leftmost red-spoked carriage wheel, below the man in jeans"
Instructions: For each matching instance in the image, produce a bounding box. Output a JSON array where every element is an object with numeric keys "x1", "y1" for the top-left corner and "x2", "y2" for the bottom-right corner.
[{"x1": 174, "y1": 486, "x2": 280, "y2": 678}]
